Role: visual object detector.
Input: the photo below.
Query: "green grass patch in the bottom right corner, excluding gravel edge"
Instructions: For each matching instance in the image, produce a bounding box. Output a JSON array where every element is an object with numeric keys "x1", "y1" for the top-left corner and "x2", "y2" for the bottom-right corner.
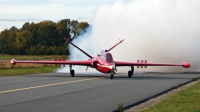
[{"x1": 140, "y1": 82, "x2": 200, "y2": 112}]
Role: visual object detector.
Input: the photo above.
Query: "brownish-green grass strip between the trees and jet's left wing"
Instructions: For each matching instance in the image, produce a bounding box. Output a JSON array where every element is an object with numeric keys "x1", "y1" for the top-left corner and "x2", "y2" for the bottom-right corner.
[{"x1": 0, "y1": 54, "x2": 68, "y2": 60}]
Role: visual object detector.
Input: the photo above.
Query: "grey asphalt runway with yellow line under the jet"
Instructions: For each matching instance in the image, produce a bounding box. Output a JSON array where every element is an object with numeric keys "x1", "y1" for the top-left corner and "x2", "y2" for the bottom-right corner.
[{"x1": 0, "y1": 73, "x2": 200, "y2": 112}]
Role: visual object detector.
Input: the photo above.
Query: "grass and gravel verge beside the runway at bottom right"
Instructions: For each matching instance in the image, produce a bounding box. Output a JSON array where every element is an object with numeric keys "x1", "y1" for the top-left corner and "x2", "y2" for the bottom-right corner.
[{"x1": 126, "y1": 78, "x2": 200, "y2": 112}]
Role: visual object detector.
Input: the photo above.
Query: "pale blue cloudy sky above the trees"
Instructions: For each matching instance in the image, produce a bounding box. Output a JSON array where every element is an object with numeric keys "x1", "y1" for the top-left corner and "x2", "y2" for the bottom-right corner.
[{"x1": 0, "y1": 0, "x2": 133, "y2": 31}]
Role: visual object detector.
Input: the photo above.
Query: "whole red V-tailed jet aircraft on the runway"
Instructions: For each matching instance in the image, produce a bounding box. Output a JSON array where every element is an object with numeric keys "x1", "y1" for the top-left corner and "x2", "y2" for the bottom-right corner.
[{"x1": 11, "y1": 38, "x2": 190, "y2": 79}]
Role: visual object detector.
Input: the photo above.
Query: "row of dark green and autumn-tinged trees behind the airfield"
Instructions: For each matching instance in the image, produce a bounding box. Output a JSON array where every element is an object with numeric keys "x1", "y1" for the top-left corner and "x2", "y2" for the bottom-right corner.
[{"x1": 0, "y1": 19, "x2": 89, "y2": 55}]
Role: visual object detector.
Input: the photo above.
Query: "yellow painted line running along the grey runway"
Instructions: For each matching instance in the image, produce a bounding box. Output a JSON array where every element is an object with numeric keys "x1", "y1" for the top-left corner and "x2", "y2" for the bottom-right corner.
[{"x1": 0, "y1": 75, "x2": 125, "y2": 94}]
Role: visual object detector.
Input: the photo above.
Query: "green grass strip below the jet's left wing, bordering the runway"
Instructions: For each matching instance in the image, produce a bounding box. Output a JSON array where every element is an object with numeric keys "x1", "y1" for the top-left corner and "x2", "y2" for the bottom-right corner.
[{"x1": 0, "y1": 66, "x2": 58, "y2": 76}]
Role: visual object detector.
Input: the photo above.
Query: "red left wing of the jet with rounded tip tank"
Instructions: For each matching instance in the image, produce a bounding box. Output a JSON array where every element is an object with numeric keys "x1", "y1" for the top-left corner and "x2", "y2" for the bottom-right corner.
[{"x1": 11, "y1": 59, "x2": 92, "y2": 66}]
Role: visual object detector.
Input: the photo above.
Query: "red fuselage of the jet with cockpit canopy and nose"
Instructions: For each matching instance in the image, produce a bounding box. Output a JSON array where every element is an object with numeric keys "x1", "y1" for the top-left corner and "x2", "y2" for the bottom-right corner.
[{"x1": 91, "y1": 51, "x2": 115, "y2": 73}]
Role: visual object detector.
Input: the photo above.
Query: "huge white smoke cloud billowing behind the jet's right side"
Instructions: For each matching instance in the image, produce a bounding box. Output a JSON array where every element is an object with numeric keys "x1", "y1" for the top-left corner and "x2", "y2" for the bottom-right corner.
[{"x1": 57, "y1": 0, "x2": 200, "y2": 72}]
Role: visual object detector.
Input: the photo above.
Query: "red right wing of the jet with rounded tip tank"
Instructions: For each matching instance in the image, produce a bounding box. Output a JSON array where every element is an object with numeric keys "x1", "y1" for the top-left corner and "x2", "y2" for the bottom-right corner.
[{"x1": 115, "y1": 61, "x2": 190, "y2": 68}]
